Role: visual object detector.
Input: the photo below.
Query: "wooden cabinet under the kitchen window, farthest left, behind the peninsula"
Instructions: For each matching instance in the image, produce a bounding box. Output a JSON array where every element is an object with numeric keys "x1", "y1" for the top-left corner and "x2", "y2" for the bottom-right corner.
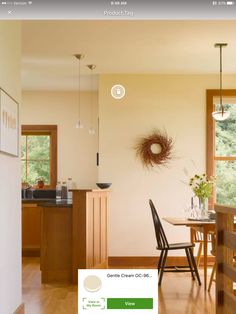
[{"x1": 22, "y1": 203, "x2": 41, "y2": 256}]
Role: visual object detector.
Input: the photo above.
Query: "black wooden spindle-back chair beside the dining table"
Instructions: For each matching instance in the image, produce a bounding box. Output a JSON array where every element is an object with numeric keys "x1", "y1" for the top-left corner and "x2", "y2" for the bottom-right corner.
[{"x1": 149, "y1": 200, "x2": 201, "y2": 286}]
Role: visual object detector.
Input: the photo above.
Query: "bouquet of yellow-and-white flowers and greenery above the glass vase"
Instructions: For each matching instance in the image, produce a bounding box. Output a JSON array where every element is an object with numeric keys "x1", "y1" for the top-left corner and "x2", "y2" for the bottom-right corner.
[{"x1": 189, "y1": 173, "x2": 216, "y2": 201}]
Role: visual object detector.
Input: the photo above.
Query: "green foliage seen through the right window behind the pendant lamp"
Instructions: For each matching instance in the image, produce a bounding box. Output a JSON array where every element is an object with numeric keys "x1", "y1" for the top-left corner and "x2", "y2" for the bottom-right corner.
[{"x1": 216, "y1": 104, "x2": 236, "y2": 205}]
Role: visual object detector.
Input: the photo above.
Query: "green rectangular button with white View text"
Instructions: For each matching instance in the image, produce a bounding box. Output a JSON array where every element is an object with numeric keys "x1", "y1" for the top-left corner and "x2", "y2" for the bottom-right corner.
[{"x1": 107, "y1": 298, "x2": 153, "y2": 310}]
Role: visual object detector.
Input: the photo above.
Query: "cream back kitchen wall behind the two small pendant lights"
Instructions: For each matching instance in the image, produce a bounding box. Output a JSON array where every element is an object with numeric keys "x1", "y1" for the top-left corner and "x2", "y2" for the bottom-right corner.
[{"x1": 22, "y1": 91, "x2": 98, "y2": 188}]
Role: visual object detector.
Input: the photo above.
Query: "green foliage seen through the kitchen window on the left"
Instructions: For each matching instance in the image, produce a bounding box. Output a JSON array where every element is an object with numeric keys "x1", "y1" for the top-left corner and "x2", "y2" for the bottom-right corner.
[{"x1": 21, "y1": 135, "x2": 50, "y2": 185}]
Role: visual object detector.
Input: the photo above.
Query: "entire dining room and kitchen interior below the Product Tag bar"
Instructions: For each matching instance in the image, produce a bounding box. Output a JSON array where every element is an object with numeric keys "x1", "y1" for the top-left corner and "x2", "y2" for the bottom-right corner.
[{"x1": 0, "y1": 20, "x2": 236, "y2": 314}]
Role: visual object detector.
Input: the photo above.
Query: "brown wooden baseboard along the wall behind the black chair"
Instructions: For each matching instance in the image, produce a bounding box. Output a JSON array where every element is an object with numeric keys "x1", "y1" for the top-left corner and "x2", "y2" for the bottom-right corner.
[{"x1": 108, "y1": 256, "x2": 215, "y2": 268}]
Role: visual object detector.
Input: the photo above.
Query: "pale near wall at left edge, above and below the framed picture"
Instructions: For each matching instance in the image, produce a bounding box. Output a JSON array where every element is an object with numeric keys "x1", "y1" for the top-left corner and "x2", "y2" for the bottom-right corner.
[{"x1": 0, "y1": 21, "x2": 21, "y2": 314}]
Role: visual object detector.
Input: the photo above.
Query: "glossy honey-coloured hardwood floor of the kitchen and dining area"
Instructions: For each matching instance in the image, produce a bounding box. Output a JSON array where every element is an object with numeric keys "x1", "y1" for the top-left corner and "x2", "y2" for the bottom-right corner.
[{"x1": 23, "y1": 257, "x2": 215, "y2": 314}]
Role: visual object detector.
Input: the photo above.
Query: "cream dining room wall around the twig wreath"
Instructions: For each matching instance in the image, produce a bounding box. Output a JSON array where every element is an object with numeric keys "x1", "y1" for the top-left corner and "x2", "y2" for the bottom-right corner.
[{"x1": 99, "y1": 75, "x2": 236, "y2": 256}]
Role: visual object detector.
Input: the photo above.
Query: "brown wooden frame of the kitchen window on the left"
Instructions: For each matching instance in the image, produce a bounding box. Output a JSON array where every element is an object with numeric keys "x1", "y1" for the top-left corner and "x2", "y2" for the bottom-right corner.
[{"x1": 21, "y1": 125, "x2": 57, "y2": 189}]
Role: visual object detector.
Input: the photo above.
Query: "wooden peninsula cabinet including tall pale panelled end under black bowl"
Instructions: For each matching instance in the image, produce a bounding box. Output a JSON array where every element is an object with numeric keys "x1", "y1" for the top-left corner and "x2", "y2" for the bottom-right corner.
[{"x1": 40, "y1": 190, "x2": 109, "y2": 284}]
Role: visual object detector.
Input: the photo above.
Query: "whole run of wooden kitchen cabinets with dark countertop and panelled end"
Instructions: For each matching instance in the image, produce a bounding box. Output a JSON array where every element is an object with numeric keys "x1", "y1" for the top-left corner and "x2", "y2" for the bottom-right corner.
[{"x1": 22, "y1": 189, "x2": 110, "y2": 284}]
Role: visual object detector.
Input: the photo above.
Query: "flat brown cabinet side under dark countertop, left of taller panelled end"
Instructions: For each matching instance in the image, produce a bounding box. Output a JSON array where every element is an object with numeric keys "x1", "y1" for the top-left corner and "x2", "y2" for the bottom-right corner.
[{"x1": 40, "y1": 207, "x2": 72, "y2": 283}]
